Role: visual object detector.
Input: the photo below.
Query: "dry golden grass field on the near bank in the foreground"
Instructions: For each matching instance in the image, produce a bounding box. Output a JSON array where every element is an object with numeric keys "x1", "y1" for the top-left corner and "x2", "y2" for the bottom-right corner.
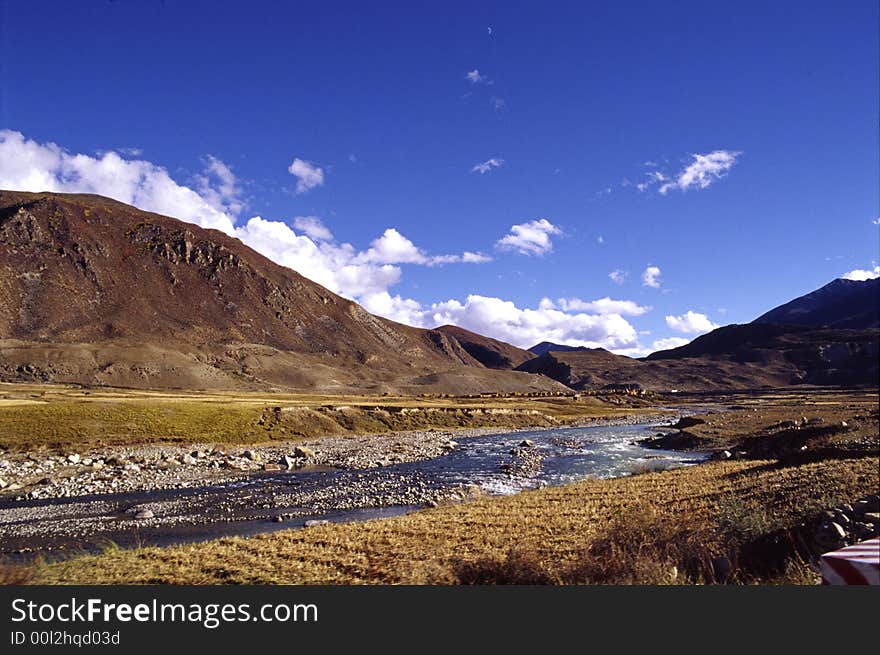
[{"x1": 25, "y1": 457, "x2": 880, "y2": 584}]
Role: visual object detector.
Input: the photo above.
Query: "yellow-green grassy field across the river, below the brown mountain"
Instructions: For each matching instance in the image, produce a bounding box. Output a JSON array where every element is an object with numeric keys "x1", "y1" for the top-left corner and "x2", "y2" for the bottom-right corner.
[{"x1": 0, "y1": 384, "x2": 656, "y2": 450}]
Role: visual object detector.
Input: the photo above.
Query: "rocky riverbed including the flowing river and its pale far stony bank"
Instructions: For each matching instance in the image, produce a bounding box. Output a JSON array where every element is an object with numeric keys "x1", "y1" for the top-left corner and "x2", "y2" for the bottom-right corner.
[{"x1": 0, "y1": 417, "x2": 701, "y2": 556}]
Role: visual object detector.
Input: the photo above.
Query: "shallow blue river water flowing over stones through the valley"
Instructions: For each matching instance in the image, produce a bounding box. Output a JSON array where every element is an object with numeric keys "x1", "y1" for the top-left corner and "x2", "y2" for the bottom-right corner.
[{"x1": 0, "y1": 425, "x2": 706, "y2": 557}]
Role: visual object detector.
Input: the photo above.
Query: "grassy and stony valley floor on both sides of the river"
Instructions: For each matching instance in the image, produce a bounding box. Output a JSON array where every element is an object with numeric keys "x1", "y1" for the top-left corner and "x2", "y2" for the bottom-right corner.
[{"x1": 0, "y1": 385, "x2": 880, "y2": 584}]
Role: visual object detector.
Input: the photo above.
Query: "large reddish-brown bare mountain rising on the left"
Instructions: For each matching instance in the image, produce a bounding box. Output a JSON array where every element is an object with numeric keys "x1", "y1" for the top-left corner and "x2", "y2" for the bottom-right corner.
[{"x1": 0, "y1": 191, "x2": 560, "y2": 393}]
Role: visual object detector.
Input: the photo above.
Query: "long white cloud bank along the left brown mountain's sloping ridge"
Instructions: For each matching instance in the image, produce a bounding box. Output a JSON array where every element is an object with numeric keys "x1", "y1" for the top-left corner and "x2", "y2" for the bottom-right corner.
[{"x1": 0, "y1": 130, "x2": 491, "y2": 308}]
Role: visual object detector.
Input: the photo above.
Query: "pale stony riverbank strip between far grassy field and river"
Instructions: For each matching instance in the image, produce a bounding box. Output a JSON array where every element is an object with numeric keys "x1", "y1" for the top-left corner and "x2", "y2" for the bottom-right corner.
[{"x1": 0, "y1": 411, "x2": 677, "y2": 501}]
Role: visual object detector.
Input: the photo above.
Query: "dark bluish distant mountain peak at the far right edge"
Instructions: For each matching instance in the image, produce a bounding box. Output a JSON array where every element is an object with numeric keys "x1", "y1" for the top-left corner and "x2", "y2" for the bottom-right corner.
[{"x1": 752, "y1": 278, "x2": 880, "y2": 330}]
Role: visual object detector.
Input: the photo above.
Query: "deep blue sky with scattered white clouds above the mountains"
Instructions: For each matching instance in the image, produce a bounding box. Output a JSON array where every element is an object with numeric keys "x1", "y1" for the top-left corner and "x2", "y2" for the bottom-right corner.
[{"x1": 0, "y1": 0, "x2": 880, "y2": 354}]
